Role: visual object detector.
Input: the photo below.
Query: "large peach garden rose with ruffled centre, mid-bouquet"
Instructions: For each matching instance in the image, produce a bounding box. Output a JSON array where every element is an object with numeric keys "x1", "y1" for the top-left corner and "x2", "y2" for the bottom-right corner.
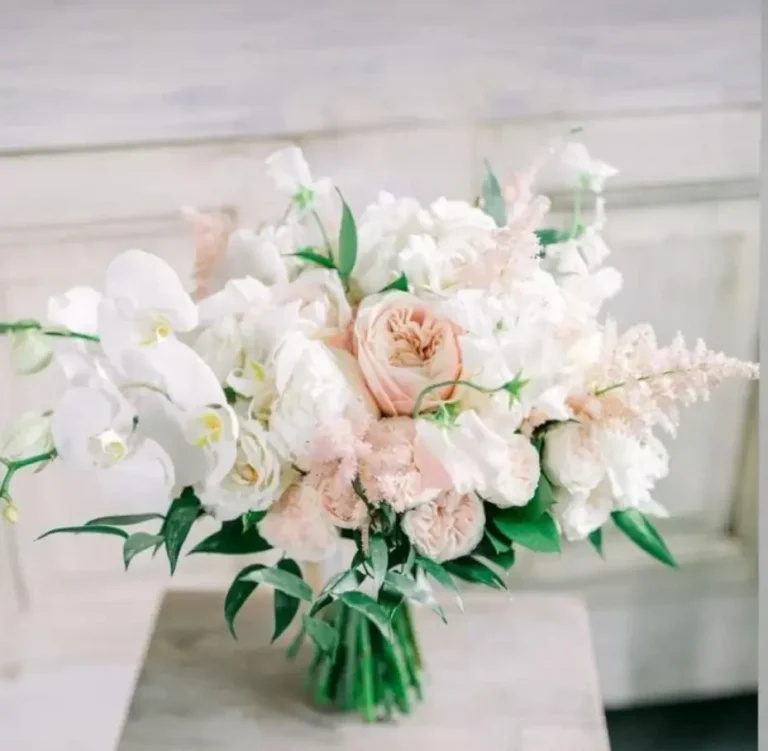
[{"x1": 354, "y1": 291, "x2": 461, "y2": 416}]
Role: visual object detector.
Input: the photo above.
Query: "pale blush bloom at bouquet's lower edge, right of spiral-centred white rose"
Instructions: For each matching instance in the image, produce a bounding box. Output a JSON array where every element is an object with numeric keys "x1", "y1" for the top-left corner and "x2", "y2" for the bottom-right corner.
[{"x1": 259, "y1": 482, "x2": 339, "y2": 561}]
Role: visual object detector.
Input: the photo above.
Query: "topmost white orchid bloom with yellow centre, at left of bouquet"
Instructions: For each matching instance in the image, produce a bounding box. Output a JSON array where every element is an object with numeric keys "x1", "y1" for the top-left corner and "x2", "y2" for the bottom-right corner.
[{"x1": 98, "y1": 250, "x2": 198, "y2": 372}]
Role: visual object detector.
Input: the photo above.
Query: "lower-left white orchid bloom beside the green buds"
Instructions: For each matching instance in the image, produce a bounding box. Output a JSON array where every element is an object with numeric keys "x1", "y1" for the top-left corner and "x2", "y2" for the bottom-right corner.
[{"x1": 51, "y1": 382, "x2": 175, "y2": 511}]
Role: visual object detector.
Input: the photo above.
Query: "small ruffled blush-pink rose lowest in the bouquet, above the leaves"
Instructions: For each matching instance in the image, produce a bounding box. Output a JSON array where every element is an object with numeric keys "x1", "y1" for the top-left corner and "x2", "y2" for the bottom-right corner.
[{"x1": 402, "y1": 490, "x2": 485, "y2": 562}]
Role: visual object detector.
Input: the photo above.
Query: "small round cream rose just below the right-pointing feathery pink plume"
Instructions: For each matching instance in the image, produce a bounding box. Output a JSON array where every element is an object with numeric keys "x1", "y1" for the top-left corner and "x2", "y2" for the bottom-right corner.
[{"x1": 542, "y1": 422, "x2": 605, "y2": 493}]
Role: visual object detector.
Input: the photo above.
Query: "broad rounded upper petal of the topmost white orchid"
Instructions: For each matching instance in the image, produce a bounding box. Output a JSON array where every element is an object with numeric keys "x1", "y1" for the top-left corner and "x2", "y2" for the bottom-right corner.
[{"x1": 105, "y1": 250, "x2": 197, "y2": 331}]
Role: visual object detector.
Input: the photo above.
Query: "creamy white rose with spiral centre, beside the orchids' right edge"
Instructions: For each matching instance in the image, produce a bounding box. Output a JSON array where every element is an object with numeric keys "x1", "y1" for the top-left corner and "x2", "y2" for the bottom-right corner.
[{"x1": 198, "y1": 420, "x2": 285, "y2": 521}]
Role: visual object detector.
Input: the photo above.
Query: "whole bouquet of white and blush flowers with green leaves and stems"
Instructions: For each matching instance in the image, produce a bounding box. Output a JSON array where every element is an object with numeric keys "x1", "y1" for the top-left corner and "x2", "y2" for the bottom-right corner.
[{"x1": 0, "y1": 141, "x2": 758, "y2": 721}]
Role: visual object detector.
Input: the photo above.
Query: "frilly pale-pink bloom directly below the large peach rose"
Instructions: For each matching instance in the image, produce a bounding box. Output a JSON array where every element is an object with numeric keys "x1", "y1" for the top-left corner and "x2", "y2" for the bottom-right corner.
[{"x1": 360, "y1": 417, "x2": 445, "y2": 513}]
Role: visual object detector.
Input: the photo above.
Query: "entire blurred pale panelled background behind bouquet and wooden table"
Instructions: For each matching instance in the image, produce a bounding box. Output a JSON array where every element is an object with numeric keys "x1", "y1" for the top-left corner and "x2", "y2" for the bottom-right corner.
[{"x1": 0, "y1": 0, "x2": 760, "y2": 751}]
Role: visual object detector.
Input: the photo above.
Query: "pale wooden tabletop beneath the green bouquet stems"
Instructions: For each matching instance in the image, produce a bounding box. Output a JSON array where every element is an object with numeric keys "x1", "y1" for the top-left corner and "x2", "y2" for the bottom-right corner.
[{"x1": 118, "y1": 592, "x2": 609, "y2": 751}]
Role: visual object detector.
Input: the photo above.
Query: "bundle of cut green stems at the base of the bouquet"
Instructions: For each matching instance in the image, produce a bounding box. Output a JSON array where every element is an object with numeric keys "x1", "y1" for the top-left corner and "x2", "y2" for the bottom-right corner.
[{"x1": 307, "y1": 601, "x2": 422, "y2": 722}]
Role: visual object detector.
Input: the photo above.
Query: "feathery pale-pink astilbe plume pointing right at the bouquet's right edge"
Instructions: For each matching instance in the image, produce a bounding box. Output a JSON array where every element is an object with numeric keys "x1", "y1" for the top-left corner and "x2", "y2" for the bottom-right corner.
[{"x1": 584, "y1": 321, "x2": 759, "y2": 434}]
